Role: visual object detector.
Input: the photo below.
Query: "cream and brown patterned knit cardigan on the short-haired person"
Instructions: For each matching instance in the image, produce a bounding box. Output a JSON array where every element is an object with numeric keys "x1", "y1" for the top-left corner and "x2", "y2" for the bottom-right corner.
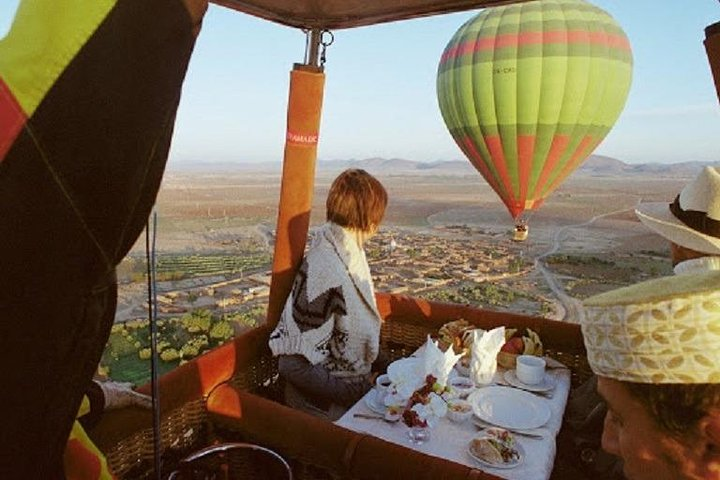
[{"x1": 269, "y1": 223, "x2": 381, "y2": 377}]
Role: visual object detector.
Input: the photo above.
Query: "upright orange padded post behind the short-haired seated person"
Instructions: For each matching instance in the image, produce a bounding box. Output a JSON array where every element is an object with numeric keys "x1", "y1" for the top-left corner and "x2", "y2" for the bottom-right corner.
[{"x1": 267, "y1": 64, "x2": 325, "y2": 327}]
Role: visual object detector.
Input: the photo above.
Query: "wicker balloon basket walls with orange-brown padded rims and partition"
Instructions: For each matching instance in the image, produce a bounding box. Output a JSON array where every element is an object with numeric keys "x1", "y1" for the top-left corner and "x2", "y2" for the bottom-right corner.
[{"x1": 94, "y1": 294, "x2": 591, "y2": 480}]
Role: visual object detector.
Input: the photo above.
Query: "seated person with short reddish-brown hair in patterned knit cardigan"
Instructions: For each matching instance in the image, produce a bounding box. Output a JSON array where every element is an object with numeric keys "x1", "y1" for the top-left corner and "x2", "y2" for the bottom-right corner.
[{"x1": 269, "y1": 169, "x2": 388, "y2": 420}]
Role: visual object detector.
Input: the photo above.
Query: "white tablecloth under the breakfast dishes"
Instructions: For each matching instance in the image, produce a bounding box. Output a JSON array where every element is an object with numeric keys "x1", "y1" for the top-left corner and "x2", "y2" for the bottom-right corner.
[{"x1": 335, "y1": 360, "x2": 570, "y2": 480}]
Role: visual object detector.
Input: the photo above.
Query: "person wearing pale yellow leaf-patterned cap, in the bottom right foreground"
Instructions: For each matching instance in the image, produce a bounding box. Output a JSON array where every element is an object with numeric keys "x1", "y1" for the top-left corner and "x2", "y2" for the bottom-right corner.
[{"x1": 581, "y1": 271, "x2": 720, "y2": 480}]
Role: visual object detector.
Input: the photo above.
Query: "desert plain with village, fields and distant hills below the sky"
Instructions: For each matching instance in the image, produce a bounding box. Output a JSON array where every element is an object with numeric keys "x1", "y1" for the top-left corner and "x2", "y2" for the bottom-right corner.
[{"x1": 101, "y1": 157, "x2": 702, "y2": 383}]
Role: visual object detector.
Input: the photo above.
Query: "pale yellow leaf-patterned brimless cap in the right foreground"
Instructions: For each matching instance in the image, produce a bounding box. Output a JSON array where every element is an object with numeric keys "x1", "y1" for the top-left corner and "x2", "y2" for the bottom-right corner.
[{"x1": 582, "y1": 271, "x2": 720, "y2": 383}]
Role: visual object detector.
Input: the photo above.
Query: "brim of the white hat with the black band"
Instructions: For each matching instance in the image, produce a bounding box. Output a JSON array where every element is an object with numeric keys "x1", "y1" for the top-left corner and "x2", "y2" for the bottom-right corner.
[{"x1": 635, "y1": 203, "x2": 720, "y2": 255}]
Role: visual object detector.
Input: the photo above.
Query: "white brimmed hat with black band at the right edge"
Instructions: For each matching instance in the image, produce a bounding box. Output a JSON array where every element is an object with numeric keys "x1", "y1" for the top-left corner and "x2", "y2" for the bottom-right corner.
[{"x1": 635, "y1": 167, "x2": 720, "y2": 255}]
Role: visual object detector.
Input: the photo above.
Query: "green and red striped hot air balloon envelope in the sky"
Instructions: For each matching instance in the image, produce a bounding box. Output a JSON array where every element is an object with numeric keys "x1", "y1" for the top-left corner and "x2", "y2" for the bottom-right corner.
[{"x1": 437, "y1": 0, "x2": 633, "y2": 218}]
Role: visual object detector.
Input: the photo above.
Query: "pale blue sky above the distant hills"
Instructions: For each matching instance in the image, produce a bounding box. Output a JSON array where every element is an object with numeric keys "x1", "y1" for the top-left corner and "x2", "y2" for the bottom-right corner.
[{"x1": 0, "y1": 0, "x2": 720, "y2": 165}]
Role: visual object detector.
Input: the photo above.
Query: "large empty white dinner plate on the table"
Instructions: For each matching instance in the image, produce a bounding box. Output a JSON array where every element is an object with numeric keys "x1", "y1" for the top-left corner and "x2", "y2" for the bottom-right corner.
[{"x1": 468, "y1": 386, "x2": 550, "y2": 430}]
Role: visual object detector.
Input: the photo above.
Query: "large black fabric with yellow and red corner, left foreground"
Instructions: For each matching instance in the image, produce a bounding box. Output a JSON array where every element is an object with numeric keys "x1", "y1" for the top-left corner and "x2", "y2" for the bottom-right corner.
[{"x1": 0, "y1": 0, "x2": 202, "y2": 479}]
